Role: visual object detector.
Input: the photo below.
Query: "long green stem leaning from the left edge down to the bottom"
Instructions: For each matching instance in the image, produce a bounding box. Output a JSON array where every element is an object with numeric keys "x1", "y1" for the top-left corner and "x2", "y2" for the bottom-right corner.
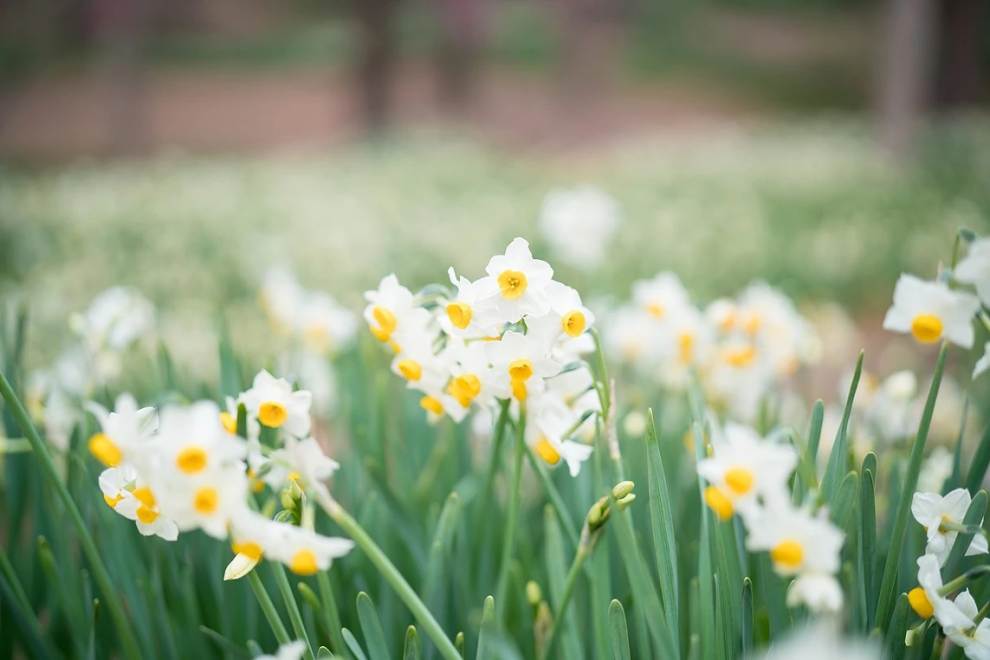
[{"x1": 0, "y1": 373, "x2": 142, "y2": 660}]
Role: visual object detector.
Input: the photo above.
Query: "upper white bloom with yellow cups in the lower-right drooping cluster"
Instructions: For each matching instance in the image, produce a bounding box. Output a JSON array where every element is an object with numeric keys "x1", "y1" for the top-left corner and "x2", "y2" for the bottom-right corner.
[{"x1": 698, "y1": 423, "x2": 797, "y2": 520}]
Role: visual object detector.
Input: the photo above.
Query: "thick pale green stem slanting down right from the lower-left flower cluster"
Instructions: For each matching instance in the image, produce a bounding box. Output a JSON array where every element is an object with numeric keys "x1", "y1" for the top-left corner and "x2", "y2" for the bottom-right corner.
[{"x1": 315, "y1": 490, "x2": 461, "y2": 660}]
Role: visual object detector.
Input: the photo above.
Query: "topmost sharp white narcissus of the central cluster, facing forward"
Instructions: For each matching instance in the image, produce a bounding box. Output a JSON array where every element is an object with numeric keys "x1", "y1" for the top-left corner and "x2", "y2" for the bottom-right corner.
[{"x1": 479, "y1": 238, "x2": 553, "y2": 323}]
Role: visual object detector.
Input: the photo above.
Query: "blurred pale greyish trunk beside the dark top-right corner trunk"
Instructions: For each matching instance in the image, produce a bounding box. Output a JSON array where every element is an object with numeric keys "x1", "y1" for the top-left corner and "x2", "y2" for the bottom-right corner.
[{"x1": 879, "y1": 0, "x2": 936, "y2": 154}]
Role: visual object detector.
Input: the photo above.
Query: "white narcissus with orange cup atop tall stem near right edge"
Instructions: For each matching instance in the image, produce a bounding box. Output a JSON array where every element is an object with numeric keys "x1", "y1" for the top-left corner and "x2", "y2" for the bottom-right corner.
[{"x1": 883, "y1": 275, "x2": 980, "y2": 348}]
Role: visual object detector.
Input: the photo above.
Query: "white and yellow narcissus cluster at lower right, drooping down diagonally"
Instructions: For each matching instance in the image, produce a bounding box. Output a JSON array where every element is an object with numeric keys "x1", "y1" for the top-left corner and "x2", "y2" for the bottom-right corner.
[{"x1": 698, "y1": 423, "x2": 843, "y2": 612}]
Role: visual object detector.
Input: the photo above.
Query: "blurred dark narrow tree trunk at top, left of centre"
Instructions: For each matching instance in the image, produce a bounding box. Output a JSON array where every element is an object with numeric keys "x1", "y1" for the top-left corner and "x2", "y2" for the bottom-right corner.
[{"x1": 354, "y1": 0, "x2": 399, "y2": 134}]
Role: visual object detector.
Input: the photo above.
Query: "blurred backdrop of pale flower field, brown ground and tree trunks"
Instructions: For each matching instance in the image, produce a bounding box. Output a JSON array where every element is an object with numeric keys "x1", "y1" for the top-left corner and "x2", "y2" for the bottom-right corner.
[{"x1": 0, "y1": 0, "x2": 990, "y2": 392}]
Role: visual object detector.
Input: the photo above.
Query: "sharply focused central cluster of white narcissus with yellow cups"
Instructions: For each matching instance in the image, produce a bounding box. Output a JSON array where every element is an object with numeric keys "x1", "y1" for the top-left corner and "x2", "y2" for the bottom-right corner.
[{"x1": 364, "y1": 238, "x2": 599, "y2": 474}]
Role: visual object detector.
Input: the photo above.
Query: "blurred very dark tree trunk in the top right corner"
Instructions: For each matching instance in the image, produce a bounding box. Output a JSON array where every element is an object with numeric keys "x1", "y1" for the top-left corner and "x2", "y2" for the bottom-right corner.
[{"x1": 935, "y1": 0, "x2": 990, "y2": 109}]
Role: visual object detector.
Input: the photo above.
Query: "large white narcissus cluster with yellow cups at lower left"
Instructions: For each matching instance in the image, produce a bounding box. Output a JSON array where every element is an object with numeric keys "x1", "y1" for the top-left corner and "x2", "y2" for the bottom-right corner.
[{"x1": 88, "y1": 371, "x2": 352, "y2": 577}]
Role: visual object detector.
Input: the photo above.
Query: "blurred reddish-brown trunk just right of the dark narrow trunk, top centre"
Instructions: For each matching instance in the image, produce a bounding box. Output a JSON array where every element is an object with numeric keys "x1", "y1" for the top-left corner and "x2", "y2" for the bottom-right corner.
[{"x1": 436, "y1": 0, "x2": 488, "y2": 111}]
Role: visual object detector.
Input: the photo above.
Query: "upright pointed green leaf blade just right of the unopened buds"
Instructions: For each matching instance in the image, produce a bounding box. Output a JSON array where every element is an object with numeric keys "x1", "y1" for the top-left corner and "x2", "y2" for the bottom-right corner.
[{"x1": 646, "y1": 408, "x2": 680, "y2": 639}]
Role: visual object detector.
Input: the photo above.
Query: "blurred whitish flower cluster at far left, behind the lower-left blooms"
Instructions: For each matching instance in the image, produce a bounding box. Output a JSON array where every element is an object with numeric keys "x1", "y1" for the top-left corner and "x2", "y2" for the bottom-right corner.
[{"x1": 28, "y1": 286, "x2": 155, "y2": 449}]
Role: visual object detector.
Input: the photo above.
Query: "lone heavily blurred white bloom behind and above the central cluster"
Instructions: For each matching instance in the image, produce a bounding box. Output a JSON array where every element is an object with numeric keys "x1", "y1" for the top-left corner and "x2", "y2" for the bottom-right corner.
[{"x1": 539, "y1": 186, "x2": 619, "y2": 270}]
